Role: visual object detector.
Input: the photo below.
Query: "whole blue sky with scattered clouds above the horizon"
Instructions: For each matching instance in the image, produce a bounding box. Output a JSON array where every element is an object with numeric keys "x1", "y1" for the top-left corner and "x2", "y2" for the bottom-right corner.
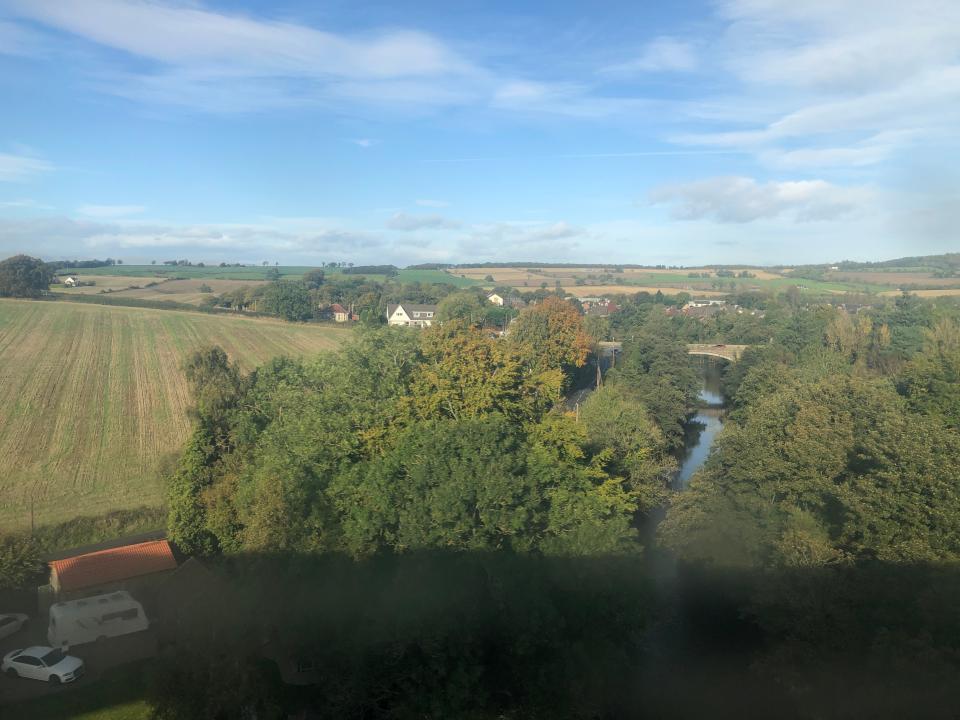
[{"x1": 0, "y1": 0, "x2": 960, "y2": 266}]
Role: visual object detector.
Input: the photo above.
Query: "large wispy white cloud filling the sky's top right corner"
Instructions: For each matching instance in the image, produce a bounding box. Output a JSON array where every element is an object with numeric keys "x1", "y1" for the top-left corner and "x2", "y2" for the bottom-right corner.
[{"x1": 673, "y1": 0, "x2": 960, "y2": 168}]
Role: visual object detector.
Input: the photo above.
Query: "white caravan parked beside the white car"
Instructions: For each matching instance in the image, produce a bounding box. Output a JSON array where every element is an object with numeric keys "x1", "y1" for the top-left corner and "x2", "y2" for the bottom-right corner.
[{"x1": 47, "y1": 590, "x2": 150, "y2": 647}]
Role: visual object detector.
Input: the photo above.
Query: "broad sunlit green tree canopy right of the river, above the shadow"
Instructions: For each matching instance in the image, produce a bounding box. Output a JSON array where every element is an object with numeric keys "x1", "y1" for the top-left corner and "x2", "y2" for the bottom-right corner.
[{"x1": 661, "y1": 374, "x2": 960, "y2": 565}]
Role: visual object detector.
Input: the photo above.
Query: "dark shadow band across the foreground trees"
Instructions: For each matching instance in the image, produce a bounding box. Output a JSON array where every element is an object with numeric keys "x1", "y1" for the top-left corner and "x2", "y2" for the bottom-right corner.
[{"x1": 150, "y1": 552, "x2": 960, "y2": 718}]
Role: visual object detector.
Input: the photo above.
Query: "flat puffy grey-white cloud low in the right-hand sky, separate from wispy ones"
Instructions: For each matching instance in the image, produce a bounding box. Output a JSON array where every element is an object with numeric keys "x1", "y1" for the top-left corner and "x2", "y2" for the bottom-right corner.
[{"x1": 650, "y1": 177, "x2": 876, "y2": 223}]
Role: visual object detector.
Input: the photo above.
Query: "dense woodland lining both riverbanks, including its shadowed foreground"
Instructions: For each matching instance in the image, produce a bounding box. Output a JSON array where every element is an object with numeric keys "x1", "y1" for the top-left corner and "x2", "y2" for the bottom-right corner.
[{"x1": 0, "y1": 258, "x2": 960, "y2": 719}]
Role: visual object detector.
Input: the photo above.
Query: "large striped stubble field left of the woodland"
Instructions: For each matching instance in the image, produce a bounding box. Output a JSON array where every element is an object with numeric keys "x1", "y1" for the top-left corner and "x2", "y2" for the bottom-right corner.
[{"x1": 0, "y1": 300, "x2": 351, "y2": 528}]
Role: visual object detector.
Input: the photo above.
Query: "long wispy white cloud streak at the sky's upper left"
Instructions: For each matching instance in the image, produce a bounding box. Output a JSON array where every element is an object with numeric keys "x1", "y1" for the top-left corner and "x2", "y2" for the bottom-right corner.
[{"x1": 8, "y1": 0, "x2": 489, "y2": 112}]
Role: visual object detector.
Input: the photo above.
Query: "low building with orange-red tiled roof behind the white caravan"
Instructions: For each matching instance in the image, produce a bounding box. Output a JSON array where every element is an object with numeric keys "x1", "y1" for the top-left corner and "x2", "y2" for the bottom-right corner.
[{"x1": 50, "y1": 540, "x2": 177, "y2": 598}]
